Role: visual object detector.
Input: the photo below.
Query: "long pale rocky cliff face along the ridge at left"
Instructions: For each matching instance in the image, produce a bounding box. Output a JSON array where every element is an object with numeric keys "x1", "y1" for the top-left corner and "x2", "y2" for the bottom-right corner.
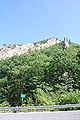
[{"x1": 0, "y1": 38, "x2": 60, "y2": 59}]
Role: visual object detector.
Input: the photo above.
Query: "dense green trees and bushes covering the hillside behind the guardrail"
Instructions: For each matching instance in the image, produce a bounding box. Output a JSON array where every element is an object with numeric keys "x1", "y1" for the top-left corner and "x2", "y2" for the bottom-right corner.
[{"x1": 0, "y1": 42, "x2": 80, "y2": 106}]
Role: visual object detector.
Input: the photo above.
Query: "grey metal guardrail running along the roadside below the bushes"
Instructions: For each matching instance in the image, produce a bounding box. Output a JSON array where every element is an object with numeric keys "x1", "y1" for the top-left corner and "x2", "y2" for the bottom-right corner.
[{"x1": 0, "y1": 104, "x2": 80, "y2": 112}]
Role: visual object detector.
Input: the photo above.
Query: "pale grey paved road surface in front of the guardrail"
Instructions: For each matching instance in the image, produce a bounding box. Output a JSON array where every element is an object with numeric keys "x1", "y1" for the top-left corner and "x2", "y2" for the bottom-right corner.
[{"x1": 0, "y1": 110, "x2": 80, "y2": 120}]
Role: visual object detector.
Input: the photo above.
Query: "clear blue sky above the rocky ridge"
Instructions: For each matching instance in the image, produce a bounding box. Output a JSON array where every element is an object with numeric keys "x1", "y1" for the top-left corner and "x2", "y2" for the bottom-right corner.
[{"x1": 0, "y1": 0, "x2": 80, "y2": 46}]
